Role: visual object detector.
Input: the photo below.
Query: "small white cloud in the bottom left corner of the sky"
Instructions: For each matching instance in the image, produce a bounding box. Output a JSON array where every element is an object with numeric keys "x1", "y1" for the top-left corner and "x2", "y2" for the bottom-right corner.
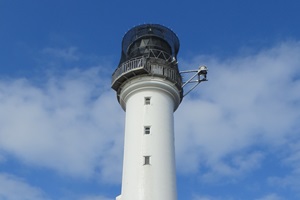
[{"x1": 0, "y1": 173, "x2": 48, "y2": 200}]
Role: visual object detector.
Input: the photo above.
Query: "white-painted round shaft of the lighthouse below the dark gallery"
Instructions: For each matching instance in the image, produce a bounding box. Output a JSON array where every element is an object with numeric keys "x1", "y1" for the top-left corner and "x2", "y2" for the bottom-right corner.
[{"x1": 117, "y1": 76, "x2": 180, "y2": 200}]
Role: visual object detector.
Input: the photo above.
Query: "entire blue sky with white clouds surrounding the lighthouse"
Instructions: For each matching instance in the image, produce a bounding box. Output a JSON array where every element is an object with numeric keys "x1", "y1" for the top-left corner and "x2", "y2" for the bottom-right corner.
[{"x1": 0, "y1": 0, "x2": 300, "y2": 200}]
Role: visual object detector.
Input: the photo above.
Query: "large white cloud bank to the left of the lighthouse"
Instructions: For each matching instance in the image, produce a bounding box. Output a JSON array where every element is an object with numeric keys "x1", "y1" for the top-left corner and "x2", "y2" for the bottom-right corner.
[{"x1": 0, "y1": 67, "x2": 124, "y2": 182}]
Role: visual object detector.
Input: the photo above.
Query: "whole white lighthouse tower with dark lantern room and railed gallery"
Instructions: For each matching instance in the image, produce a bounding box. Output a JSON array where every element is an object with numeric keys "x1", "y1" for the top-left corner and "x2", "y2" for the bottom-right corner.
[{"x1": 112, "y1": 24, "x2": 207, "y2": 200}]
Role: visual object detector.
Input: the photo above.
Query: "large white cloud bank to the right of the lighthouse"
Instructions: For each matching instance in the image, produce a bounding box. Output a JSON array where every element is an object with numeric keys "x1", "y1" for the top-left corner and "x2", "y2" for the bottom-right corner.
[{"x1": 175, "y1": 41, "x2": 300, "y2": 181}]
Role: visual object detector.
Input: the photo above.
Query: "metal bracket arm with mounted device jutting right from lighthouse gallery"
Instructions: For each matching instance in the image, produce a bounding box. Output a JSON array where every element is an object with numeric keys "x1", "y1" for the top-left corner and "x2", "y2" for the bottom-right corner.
[{"x1": 180, "y1": 65, "x2": 208, "y2": 97}]
